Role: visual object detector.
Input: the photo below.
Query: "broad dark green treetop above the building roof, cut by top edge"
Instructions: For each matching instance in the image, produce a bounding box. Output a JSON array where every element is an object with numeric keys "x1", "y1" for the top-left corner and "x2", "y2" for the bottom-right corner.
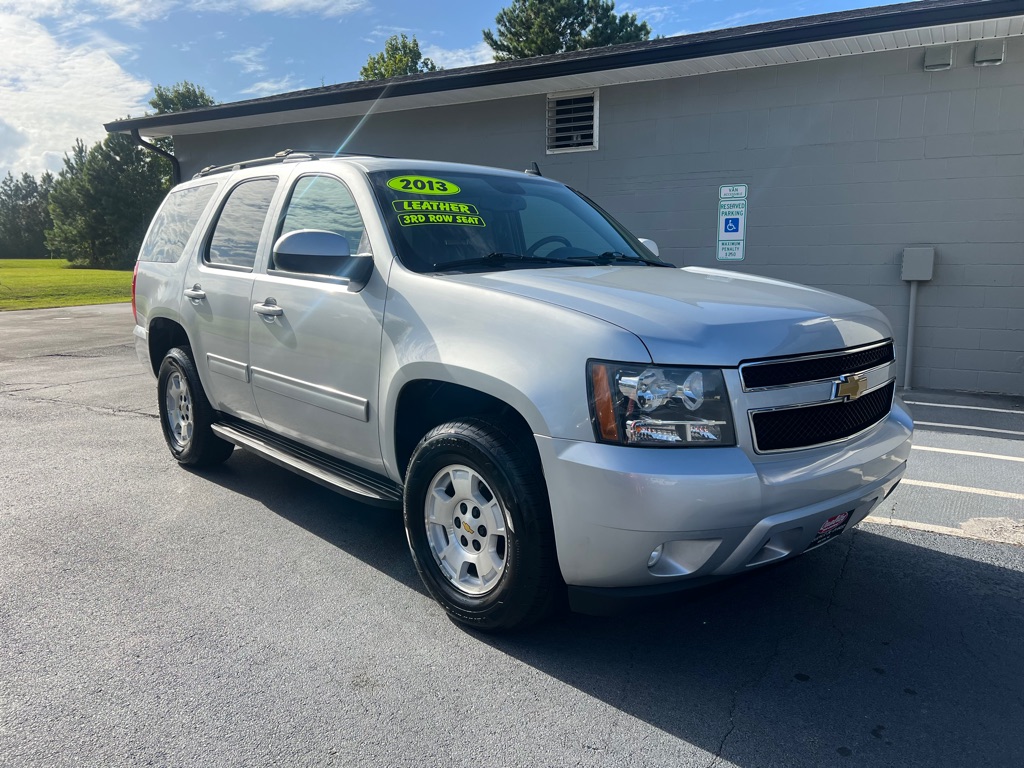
[{"x1": 483, "y1": 0, "x2": 650, "y2": 61}]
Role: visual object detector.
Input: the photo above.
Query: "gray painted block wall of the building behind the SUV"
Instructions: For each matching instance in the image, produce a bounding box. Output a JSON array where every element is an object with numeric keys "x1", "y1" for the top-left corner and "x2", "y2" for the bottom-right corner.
[{"x1": 178, "y1": 38, "x2": 1024, "y2": 394}]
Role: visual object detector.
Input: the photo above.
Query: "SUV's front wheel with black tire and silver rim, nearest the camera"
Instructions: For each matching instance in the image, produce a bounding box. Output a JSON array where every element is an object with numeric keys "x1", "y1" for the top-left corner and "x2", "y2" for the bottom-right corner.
[{"x1": 403, "y1": 419, "x2": 565, "y2": 632}]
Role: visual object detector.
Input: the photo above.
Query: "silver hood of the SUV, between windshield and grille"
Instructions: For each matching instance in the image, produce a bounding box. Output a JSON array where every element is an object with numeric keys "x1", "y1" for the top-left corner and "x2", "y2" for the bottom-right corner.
[{"x1": 444, "y1": 266, "x2": 891, "y2": 367}]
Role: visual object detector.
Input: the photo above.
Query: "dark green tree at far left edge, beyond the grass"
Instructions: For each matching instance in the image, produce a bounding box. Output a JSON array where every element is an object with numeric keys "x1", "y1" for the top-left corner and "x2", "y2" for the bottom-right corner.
[{"x1": 0, "y1": 172, "x2": 53, "y2": 259}]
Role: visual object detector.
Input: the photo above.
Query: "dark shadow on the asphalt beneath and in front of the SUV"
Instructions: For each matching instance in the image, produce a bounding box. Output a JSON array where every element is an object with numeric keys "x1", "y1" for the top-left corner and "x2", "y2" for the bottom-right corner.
[{"x1": 195, "y1": 452, "x2": 1024, "y2": 766}]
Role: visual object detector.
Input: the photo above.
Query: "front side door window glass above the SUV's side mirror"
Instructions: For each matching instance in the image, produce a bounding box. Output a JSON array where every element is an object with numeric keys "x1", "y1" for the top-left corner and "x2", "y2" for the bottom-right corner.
[{"x1": 278, "y1": 176, "x2": 370, "y2": 259}]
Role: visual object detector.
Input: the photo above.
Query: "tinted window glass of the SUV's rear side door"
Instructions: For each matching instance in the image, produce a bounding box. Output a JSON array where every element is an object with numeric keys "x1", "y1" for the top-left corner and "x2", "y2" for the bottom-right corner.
[{"x1": 206, "y1": 178, "x2": 278, "y2": 268}]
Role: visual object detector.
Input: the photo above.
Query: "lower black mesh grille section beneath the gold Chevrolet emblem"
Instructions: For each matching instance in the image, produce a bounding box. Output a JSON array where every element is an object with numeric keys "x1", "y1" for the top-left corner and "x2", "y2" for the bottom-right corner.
[{"x1": 751, "y1": 381, "x2": 896, "y2": 453}]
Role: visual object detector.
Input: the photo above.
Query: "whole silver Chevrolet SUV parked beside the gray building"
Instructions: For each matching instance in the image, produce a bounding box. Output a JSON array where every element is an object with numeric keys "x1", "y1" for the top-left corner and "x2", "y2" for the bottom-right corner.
[{"x1": 134, "y1": 153, "x2": 912, "y2": 630}]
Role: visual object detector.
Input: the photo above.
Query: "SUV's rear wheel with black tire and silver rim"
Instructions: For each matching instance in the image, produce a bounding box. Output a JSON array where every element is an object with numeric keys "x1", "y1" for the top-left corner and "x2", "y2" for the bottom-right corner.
[{"x1": 157, "y1": 347, "x2": 234, "y2": 467}]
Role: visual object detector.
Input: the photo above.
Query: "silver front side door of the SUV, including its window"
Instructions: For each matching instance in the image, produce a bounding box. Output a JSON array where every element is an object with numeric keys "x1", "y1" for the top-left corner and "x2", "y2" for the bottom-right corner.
[{"x1": 249, "y1": 173, "x2": 386, "y2": 472}]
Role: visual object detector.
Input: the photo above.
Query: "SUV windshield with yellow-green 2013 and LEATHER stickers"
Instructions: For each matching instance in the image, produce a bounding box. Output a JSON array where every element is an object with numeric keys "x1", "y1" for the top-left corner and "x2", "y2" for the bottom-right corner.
[{"x1": 370, "y1": 169, "x2": 665, "y2": 272}]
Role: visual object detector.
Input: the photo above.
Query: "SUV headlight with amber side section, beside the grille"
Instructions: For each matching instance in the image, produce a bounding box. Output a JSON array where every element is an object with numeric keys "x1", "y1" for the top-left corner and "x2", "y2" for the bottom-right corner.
[{"x1": 587, "y1": 360, "x2": 736, "y2": 447}]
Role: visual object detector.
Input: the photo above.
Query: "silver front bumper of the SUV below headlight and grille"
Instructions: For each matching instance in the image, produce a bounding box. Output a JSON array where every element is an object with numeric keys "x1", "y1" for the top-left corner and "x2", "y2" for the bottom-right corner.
[{"x1": 537, "y1": 398, "x2": 912, "y2": 593}]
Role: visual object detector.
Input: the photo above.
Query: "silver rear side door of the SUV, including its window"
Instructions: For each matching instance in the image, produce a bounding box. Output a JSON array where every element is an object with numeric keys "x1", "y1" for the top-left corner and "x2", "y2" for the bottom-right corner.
[{"x1": 181, "y1": 175, "x2": 280, "y2": 423}]
